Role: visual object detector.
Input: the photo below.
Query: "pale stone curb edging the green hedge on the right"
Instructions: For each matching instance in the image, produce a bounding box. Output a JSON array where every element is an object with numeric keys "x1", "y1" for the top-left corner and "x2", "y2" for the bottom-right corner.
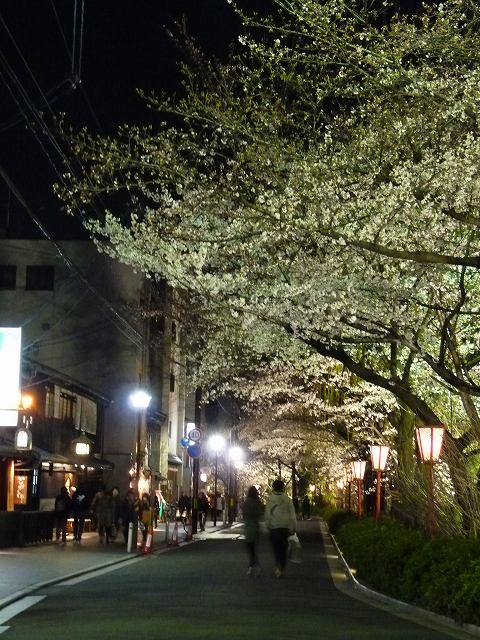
[{"x1": 321, "y1": 522, "x2": 480, "y2": 638}]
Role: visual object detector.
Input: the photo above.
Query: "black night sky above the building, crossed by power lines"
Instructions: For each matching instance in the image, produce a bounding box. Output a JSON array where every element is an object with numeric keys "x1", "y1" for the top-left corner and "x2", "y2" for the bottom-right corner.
[{"x1": 0, "y1": 0, "x2": 238, "y2": 239}]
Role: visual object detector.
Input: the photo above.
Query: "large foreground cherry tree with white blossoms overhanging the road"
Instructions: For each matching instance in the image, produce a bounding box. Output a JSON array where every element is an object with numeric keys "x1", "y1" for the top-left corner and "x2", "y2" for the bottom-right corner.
[{"x1": 59, "y1": 0, "x2": 480, "y2": 526}]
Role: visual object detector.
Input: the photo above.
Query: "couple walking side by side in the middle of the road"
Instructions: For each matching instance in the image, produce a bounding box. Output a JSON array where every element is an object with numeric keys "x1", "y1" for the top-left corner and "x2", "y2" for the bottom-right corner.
[{"x1": 243, "y1": 480, "x2": 297, "y2": 578}]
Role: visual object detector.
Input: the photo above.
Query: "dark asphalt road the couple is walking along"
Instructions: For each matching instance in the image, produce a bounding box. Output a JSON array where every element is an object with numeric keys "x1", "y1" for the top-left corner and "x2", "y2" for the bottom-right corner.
[{"x1": 0, "y1": 521, "x2": 472, "y2": 640}]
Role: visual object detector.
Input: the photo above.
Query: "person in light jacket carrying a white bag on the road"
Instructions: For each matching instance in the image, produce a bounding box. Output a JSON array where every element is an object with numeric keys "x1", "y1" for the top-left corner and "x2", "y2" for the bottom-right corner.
[{"x1": 265, "y1": 480, "x2": 297, "y2": 578}]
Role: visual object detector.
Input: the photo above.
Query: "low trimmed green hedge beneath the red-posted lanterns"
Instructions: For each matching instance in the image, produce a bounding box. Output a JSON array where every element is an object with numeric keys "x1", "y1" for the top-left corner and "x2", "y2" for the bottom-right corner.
[{"x1": 327, "y1": 512, "x2": 480, "y2": 625}]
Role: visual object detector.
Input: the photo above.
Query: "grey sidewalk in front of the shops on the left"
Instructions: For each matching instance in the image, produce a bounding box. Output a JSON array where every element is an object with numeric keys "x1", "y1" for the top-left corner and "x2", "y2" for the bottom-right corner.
[{"x1": 0, "y1": 522, "x2": 223, "y2": 609}]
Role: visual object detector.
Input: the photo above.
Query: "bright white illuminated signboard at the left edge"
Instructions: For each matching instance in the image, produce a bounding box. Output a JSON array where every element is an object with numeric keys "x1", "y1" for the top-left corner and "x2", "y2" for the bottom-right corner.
[{"x1": 0, "y1": 327, "x2": 22, "y2": 427}]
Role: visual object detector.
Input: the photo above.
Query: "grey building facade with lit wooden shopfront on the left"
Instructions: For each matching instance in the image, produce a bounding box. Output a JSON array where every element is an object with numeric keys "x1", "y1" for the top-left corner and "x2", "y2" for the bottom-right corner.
[{"x1": 0, "y1": 239, "x2": 186, "y2": 510}]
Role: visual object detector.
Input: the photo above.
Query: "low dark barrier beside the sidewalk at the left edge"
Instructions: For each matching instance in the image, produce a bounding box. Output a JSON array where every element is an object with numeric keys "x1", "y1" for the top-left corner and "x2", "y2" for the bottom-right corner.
[{"x1": 0, "y1": 511, "x2": 55, "y2": 549}]
